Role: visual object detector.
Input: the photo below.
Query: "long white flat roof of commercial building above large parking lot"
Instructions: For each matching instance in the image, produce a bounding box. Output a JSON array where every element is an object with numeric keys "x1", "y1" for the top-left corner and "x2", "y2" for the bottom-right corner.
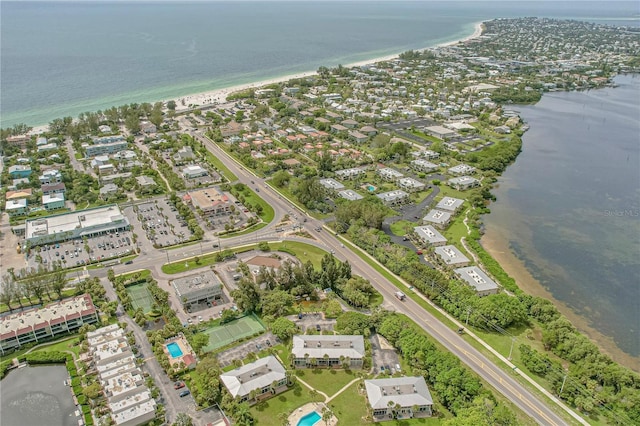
[{"x1": 26, "y1": 204, "x2": 129, "y2": 239}]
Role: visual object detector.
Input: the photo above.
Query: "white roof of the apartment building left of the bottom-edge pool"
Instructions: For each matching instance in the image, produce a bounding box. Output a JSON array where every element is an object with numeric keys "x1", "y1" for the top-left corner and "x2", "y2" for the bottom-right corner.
[{"x1": 220, "y1": 356, "x2": 286, "y2": 398}]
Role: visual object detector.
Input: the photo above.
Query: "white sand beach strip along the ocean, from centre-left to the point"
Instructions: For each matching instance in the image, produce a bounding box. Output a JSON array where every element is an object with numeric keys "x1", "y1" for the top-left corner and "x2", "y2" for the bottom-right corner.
[{"x1": 165, "y1": 22, "x2": 483, "y2": 111}]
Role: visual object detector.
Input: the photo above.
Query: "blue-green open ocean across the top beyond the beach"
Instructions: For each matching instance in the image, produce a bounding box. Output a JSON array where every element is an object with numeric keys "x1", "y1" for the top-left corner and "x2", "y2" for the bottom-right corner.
[{"x1": 0, "y1": 1, "x2": 640, "y2": 127}]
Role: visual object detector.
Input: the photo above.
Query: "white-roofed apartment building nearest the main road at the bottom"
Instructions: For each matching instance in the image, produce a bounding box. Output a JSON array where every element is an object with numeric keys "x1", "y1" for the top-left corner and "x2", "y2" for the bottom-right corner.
[{"x1": 364, "y1": 376, "x2": 433, "y2": 422}]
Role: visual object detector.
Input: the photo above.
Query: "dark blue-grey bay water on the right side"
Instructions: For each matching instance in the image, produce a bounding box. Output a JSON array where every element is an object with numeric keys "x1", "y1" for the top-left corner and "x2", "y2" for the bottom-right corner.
[{"x1": 483, "y1": 75, "x2": 640, "y2": 366}]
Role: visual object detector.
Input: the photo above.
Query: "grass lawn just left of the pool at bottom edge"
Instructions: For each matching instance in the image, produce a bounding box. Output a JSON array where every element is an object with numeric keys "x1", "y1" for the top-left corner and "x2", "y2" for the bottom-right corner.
[{"x1": 251, "y1": 383, "x2": 324, "y2": 426}]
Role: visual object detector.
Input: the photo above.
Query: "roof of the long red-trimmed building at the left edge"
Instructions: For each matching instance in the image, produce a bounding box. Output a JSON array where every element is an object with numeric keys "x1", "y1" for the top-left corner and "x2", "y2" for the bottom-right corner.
[{"x1": 0, "y1": 294, "x2": 96, "y2": 339}]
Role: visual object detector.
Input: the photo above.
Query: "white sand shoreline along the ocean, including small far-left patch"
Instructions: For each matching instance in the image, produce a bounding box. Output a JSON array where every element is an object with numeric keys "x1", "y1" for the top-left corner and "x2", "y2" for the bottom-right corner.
[{"x1": 29, "y1": 21, "x2": 484, "y2": 134}]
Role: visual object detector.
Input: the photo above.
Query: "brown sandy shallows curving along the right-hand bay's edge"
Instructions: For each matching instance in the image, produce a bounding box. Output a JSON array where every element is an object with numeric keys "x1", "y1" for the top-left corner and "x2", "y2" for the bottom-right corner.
[{"x1": 479, "y1": 226, "x2": 639, "y2": 372}]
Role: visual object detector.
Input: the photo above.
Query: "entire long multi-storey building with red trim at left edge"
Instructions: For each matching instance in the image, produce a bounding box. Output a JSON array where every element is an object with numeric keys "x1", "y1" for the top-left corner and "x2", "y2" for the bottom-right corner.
[{"x1": 0, "y1": 294, "x2": 99, "y2": 355}]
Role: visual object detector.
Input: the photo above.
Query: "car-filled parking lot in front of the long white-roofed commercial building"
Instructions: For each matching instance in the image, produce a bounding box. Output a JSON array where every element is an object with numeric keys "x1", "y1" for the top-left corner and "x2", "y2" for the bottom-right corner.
[{"x1": 27, "y1": 231, "x2": 135, "y2": 268}]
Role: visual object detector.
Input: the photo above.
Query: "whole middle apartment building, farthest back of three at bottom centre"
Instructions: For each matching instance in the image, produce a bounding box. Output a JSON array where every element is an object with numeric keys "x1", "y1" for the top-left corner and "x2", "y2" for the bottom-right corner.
[{"x1": 291, "y1": 334, "x2": 365, "y2": 368}]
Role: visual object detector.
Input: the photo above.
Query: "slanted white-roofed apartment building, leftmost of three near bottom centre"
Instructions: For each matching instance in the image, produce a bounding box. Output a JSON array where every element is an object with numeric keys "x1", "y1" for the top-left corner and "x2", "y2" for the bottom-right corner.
[{"x1": 220, "y1": 356, "x2": 287, "y2": 404}]
